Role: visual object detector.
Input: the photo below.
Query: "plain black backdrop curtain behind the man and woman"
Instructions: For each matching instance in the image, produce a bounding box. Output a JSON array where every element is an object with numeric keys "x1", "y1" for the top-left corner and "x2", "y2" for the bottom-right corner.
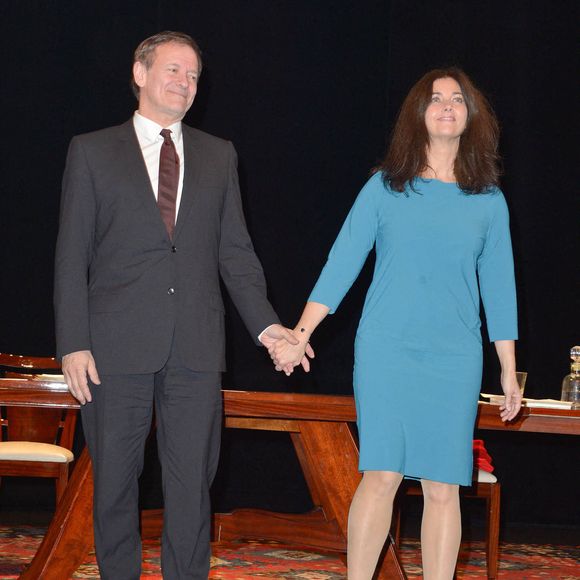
[{"x1": 0, "y1": 0, "x2": 580, "y2": 524}]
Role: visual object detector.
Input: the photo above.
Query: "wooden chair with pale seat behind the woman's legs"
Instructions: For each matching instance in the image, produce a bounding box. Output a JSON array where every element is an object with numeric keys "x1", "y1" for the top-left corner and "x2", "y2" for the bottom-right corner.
[{"x1": 393, "y1": 469, "x2": 501, "y2": 578}]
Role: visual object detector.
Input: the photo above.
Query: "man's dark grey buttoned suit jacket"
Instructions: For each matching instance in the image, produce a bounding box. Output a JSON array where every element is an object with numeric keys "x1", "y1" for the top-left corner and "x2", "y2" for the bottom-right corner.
[{"x1": 54, "y1": 120, "x2": 278, "y2": 374}]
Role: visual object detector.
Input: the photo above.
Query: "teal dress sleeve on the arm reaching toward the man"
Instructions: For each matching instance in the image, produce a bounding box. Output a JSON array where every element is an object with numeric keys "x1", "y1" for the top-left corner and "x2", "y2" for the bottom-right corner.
[{"x1": 308, "y1": 173, "x2": 385, "y2": 314}]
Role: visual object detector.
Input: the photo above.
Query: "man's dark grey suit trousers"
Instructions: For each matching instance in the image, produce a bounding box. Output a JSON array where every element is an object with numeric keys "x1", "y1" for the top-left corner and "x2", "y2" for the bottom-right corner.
[{"x1": 82, "y1": 349, "x2": 222, "y2": 580}]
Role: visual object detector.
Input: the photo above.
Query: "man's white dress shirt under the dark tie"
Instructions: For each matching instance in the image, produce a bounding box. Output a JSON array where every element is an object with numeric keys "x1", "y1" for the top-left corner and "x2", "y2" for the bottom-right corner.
[{"x1": 133, "y1": 111, "x2": 184, "y2": 220}]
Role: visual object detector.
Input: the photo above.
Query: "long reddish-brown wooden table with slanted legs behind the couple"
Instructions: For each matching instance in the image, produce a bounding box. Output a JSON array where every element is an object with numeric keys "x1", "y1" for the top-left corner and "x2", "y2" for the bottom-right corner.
[{"x1": 0, "y1": 379, "x2": 580, "y2": 580}]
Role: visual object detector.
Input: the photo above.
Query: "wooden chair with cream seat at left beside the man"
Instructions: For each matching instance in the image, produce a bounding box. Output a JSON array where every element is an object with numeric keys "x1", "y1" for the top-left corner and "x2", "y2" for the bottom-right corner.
[{"x1": 0, "y1": 353, "x2": 77, "y2": 504}]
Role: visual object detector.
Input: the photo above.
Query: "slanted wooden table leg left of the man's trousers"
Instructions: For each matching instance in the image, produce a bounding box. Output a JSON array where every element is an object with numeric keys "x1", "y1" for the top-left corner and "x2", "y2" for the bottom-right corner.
[{"x1": 20, "y1": 448, "x2": 94, "y2": 580}]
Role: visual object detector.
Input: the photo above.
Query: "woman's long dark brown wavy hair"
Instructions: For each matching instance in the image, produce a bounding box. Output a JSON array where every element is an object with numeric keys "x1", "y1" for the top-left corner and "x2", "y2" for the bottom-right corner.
[{"x1": 375, "y1": 67, "x2": 500, "y2": 193}]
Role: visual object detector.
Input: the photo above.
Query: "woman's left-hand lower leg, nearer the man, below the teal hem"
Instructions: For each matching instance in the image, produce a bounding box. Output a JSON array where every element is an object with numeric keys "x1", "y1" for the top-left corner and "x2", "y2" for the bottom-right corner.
[{"x1": 347, "y1": 471, "x2": 403, "y2": 580}]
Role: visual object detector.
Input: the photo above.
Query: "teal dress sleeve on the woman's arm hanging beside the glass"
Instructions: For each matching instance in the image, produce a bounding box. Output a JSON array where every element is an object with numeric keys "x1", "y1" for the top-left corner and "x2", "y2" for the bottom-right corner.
[{"x1": 477, "y1": 190, "x2": 518, "y2": 342}]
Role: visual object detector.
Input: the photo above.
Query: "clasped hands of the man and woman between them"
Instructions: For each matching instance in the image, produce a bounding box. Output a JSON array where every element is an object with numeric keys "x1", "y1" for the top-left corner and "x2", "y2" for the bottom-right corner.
[{"x1": 260, "y1": 324, "x2": 314, "y2": 376}]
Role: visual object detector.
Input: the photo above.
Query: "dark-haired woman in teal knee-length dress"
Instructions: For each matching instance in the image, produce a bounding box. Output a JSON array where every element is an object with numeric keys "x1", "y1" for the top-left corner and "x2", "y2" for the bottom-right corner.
[{"x1": 269, "y1": 69, "x2": 521, "y2": 580}]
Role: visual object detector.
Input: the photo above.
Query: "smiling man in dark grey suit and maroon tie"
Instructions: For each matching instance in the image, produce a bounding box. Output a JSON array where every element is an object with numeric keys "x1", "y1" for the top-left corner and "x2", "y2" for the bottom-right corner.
[{"x1": 55, "y1": 32, "x2": 308, "y2": 580}]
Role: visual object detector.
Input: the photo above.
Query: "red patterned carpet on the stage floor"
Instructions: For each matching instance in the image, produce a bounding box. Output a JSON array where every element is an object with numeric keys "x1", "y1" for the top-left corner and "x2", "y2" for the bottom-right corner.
[{"x1": 0, "y1": 526, "x2": 580, "y2": 580}]
